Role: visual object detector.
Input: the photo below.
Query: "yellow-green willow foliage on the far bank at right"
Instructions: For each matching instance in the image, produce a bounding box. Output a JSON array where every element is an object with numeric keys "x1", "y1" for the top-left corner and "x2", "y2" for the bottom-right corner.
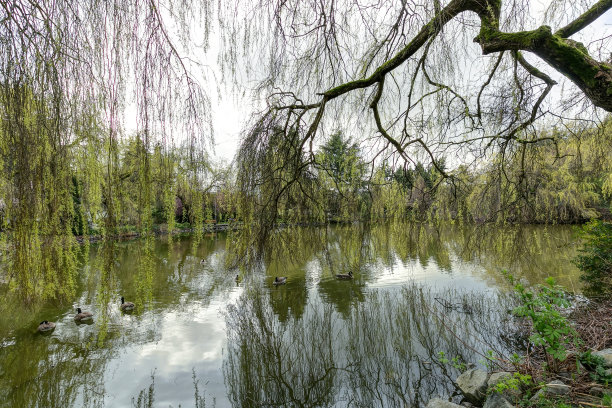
[{"x1": 436, "y1": 119, "x2": 612, "y2": 223}]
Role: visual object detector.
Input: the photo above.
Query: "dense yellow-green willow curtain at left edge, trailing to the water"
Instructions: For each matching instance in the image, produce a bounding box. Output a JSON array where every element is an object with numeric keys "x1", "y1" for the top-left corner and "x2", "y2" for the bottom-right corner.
[{"x1": 0, "y1": 82, "x2": 82, "y2": 303}]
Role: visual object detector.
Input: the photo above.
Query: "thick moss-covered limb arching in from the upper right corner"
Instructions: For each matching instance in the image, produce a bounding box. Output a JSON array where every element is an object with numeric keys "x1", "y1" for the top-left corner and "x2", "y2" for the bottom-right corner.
[{"x1": 321, "y1": 0, "x2": 612, "y2": 112}]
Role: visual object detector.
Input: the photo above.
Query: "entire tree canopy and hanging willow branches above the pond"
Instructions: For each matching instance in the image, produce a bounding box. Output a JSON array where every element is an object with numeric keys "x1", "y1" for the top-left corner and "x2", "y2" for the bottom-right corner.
[{"x1": 0, "y1": 0, "x2": 612, "y2": 298}]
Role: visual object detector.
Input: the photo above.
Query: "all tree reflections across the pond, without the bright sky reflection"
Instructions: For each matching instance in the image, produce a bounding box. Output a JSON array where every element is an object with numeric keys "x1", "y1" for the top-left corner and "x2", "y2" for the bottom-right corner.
[{"x1": 0, "y1": 224, "x2": 572, "y2": 407}]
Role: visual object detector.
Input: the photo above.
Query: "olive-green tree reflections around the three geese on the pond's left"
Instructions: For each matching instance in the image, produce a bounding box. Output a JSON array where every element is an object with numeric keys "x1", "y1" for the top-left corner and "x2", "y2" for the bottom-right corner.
[{"x1": 0, "y1": 233, "x2": 233, "y2": 407}]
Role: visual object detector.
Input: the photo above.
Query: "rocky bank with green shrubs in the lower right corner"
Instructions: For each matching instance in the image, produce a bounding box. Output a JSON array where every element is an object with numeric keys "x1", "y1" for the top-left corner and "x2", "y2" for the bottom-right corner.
[{"x1": 427, "y1": 221, "x2": 612, "y2": 408}]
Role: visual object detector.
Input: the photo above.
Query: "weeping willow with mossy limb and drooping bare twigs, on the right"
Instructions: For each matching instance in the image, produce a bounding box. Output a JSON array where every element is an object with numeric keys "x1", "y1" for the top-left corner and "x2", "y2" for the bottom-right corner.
[{"x1": 221, "y1": 0, "x2": 612, "y2": 255}]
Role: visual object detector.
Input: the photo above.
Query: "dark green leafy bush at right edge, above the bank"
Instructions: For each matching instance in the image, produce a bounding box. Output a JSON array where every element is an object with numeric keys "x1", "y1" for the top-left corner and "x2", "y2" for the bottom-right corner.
[{"x1": 574, "y1": 220, "x2": 612, "y2": 296}]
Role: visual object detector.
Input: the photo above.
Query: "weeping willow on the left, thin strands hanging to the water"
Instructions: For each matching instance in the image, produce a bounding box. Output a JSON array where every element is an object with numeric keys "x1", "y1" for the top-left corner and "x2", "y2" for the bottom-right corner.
[{"x1": 0, "y1": 0, "x2": 212, "y2": 303}]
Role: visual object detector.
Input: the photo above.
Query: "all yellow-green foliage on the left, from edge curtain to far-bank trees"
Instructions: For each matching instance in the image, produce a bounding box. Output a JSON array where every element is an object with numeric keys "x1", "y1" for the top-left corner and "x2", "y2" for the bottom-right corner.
[{"x1": 0, "y1": 84, "x2": 225, "y2": 303}]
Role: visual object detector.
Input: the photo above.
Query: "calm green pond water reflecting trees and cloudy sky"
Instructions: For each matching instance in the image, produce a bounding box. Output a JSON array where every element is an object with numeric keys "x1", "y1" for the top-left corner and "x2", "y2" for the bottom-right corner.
[{"x1": 0, "y1": 224, "x2": 579, "y2": 407}]
